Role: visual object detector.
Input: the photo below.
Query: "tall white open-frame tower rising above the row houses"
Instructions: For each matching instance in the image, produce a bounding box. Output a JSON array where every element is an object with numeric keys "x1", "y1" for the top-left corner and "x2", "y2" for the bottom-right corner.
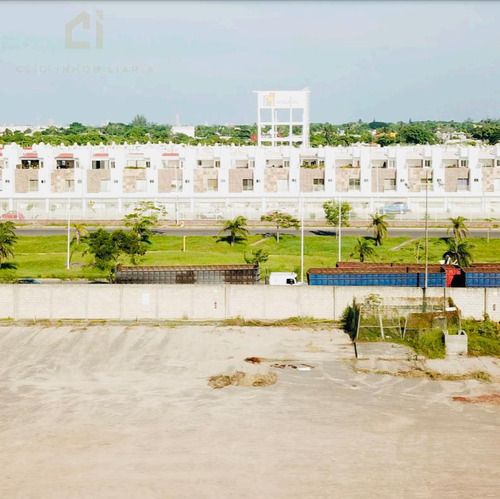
[{"x1": 254, "y1": 88, "x2": 311, "y2": 147}]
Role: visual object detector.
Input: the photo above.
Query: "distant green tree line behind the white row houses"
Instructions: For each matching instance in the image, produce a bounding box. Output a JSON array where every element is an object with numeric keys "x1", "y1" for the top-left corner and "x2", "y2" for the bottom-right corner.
[{"x1": 0, "y1": 115, "x2": 500, "y2": 147}]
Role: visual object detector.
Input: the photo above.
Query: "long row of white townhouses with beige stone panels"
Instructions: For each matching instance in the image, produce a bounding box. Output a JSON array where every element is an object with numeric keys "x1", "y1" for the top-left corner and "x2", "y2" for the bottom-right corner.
[{"x1": 0, "y1": 143, "x2": 500, "y2": 221}]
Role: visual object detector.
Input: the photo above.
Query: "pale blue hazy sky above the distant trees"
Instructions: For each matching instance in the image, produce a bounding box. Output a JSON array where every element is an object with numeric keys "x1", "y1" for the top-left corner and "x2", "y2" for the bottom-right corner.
[{"x1": 0, "y1": 0, "x2": 500, "y2": 125}]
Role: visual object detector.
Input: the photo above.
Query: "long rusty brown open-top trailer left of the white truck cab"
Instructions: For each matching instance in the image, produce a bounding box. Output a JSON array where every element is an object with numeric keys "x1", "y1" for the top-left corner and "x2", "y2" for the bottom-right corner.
[{"x1": 114, "y1": 264, "x2": 260, "y2": 284}]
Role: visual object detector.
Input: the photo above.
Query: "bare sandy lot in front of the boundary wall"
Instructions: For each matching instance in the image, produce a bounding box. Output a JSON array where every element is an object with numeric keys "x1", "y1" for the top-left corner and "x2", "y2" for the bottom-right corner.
[{"x1": 0, "y1": 325, "x2": 500, "y2": 499}]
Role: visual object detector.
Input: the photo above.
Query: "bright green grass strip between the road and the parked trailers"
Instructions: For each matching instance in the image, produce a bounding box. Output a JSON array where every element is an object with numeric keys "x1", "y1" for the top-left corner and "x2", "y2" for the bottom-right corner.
[{"x1": 0, "y1": 235, "x2": 500, "y2": 280}]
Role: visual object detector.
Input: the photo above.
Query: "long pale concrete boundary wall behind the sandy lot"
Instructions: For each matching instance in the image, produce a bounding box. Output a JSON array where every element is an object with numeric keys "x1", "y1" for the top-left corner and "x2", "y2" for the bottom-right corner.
[{"x1": 0, "y1": 284, "x2": 500, "y2": 321}]
